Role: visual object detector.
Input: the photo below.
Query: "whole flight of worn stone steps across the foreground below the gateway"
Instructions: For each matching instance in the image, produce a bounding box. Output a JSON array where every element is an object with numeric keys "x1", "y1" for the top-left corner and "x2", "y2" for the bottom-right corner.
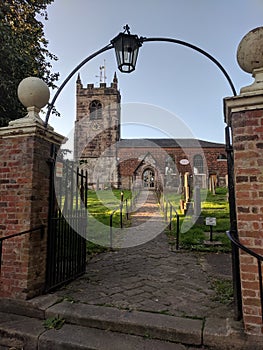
[{"x1": 0, "y1": 295, "x2": 263, "y2": 350}]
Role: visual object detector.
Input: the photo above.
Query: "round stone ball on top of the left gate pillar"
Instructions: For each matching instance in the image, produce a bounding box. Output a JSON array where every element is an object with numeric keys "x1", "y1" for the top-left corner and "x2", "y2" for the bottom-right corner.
[{"x1": 17, "y1": 77, "x2": 50, "y2": 109}]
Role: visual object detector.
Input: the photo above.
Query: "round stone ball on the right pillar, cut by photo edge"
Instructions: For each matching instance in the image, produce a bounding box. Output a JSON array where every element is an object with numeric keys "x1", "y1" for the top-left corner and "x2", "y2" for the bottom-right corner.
[{"x1": 237, "y1": 27, "x2": 263, "y2": 73}]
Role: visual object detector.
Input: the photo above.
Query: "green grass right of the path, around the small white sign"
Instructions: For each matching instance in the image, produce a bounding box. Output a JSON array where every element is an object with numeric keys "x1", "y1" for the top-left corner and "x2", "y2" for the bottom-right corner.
[{"x1": 167, "y1": 188, "x2": 231, "y2": 252}]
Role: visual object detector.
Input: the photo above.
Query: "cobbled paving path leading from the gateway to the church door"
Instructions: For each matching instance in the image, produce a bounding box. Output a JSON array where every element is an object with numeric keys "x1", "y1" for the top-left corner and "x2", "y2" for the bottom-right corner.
[{"x1": 56, "y1": 193, "x2": 233, "y2": 318}]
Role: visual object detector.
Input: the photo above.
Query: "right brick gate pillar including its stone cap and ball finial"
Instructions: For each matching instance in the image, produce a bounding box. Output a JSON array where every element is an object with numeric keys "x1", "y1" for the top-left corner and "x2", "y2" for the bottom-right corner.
[{"x1": 224, "y1": 28, "x2": 263, "y2": 335}]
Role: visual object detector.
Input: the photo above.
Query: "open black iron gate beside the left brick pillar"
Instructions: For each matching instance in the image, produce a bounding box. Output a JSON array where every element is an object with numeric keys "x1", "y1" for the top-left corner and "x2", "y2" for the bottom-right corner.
[{"x1": 45, "y1": 145, "x2": 88, "y2": 292}]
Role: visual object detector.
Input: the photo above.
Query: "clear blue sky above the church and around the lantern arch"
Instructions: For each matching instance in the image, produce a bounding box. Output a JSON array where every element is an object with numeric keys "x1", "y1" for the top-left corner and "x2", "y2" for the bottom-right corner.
[{"x1": 45, "y1": 0, "x2": 263, "y2": 142}]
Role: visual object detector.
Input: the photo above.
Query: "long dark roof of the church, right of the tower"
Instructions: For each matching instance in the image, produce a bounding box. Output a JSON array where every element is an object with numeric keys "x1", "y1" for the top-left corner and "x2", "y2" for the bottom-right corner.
[{"x1": 118, "y1": 138, "x2": 225, "y2": 148}]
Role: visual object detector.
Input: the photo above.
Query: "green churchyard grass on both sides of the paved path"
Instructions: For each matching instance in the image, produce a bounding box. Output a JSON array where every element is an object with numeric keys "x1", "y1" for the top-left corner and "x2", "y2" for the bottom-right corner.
[{"x1": 87, "y1": 188, "x2": 231, "y2": 255}]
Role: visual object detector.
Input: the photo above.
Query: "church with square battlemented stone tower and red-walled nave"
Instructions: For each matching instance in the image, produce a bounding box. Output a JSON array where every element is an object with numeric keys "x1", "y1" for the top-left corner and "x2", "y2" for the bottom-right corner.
[{"x1": 74, "y1": 73, "x2": 227, "y2": 189}]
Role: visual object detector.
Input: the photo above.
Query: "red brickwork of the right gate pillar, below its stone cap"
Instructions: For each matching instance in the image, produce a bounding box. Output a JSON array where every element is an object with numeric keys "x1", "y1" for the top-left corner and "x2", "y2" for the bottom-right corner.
[{"x1": 232, "y1": 110, "x2": 263, "y2": 333}]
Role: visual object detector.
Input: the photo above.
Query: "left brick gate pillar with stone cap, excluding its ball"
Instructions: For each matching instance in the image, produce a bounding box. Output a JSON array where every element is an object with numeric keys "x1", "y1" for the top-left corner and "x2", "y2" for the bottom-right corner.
[{"x1": 0, "y1": 78, "x2": 64, "y2": 299}]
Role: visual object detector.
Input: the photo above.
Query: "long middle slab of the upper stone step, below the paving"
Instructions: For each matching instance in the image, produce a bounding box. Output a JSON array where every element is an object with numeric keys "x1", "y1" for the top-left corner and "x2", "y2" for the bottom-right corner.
[{"x1": 46, "y1": 301, "x2": 203, "y2": 346}]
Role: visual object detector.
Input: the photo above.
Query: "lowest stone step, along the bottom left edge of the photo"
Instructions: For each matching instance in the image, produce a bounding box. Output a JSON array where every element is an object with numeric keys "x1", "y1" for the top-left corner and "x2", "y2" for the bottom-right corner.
[{"x1": 0, "y1": 313, "x2": 186, "y2": 350}]
